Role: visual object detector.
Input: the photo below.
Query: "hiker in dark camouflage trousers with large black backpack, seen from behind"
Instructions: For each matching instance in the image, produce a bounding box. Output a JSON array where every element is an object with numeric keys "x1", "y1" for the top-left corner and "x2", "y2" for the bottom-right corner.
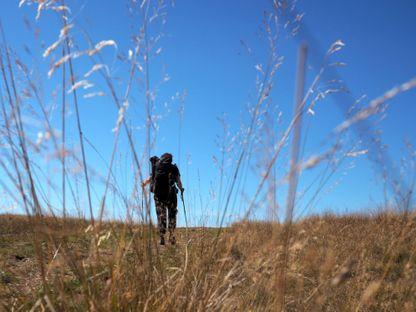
[{"x1": 142, "y1": 153, "x2": 185, "y2": 245}]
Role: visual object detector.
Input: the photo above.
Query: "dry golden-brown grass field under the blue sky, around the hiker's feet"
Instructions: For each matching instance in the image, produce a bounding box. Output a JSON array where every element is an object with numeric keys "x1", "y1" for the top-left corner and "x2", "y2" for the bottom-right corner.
[{"x1": 0, "y1": 214, "x2": 416, "y2": 311}]
